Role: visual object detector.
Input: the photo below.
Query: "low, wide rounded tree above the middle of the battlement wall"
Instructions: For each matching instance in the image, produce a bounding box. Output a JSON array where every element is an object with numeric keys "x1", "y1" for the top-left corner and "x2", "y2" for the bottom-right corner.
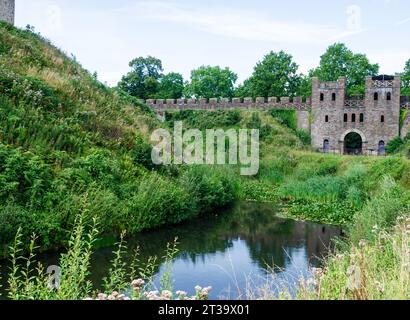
[{"x1": 185, "y1": 66, "x2": 238, "y2": 99}]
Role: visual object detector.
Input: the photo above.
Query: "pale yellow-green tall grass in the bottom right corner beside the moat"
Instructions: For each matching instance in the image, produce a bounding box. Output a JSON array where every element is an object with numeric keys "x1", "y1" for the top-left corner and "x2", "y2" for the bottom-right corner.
[{"x1": 298, "y1": 214, "x2": 410, "y2": 300}]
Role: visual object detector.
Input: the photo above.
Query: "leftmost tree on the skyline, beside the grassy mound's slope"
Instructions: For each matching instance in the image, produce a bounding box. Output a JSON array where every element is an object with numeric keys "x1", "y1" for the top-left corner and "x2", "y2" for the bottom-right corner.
[{"x1": 118, "y1": 56, "x2": 163, "y2": 99}]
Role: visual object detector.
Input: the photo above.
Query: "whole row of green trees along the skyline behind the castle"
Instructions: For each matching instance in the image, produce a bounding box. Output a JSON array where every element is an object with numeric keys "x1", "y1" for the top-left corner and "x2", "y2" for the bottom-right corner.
[{"x1": 118, "y1": 43, "x2": 388, "y2": 99}]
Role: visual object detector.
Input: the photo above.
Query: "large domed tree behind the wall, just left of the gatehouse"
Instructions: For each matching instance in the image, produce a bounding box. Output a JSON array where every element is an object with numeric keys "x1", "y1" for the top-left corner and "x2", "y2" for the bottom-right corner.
[{"x1": 237, "y1": 51, "x2": 302, "y2": 97}]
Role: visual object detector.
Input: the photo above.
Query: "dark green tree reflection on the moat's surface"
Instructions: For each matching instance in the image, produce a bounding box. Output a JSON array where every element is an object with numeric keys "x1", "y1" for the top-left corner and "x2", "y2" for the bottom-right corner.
[{"x1": 114, "y1": 203, "x2": 340, "y2": 276}]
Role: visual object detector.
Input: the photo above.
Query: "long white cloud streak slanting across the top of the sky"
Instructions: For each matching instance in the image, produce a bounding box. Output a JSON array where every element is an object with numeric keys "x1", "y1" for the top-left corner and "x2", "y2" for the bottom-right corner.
[{"x1": 117, "y1": 1, "x2": 362, "y2": 44}]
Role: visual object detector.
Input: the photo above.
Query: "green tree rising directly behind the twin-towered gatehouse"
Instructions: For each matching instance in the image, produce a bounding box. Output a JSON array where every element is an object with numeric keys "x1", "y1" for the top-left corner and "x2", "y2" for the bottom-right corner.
[{"x1": 310, "y1": 43, "x2": 379, "y2": 95}]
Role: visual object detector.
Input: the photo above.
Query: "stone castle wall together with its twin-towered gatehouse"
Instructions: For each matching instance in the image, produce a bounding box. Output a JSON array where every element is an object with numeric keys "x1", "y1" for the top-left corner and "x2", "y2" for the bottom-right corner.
[{"x1": 146, "y1": 77, "x2": 410, "y2": 154}]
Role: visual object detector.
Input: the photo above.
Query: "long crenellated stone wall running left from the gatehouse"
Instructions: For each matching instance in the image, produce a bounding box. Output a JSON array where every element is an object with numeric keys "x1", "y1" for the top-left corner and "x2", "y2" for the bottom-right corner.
[{"x1": 145, "y1": 97, "x2": 311, "y2": 111}]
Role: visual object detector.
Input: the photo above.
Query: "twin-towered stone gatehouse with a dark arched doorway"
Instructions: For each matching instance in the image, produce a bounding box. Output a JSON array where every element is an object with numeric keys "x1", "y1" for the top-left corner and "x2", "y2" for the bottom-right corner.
[{"x1": 312, "y1": 76, "x2": 400, "y2": 155}]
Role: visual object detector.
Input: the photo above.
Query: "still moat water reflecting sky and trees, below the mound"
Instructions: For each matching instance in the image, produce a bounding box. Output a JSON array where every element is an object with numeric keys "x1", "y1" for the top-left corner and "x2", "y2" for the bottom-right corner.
[{"x1": 0, "y1": 203, "x2": 342, "y2": 299}]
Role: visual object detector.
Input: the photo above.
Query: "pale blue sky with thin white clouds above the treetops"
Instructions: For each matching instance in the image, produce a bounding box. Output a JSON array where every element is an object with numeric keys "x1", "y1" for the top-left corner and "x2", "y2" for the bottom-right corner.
[{"x1": 16, "y1": 0, "x2": 410, "y2": 85}]
